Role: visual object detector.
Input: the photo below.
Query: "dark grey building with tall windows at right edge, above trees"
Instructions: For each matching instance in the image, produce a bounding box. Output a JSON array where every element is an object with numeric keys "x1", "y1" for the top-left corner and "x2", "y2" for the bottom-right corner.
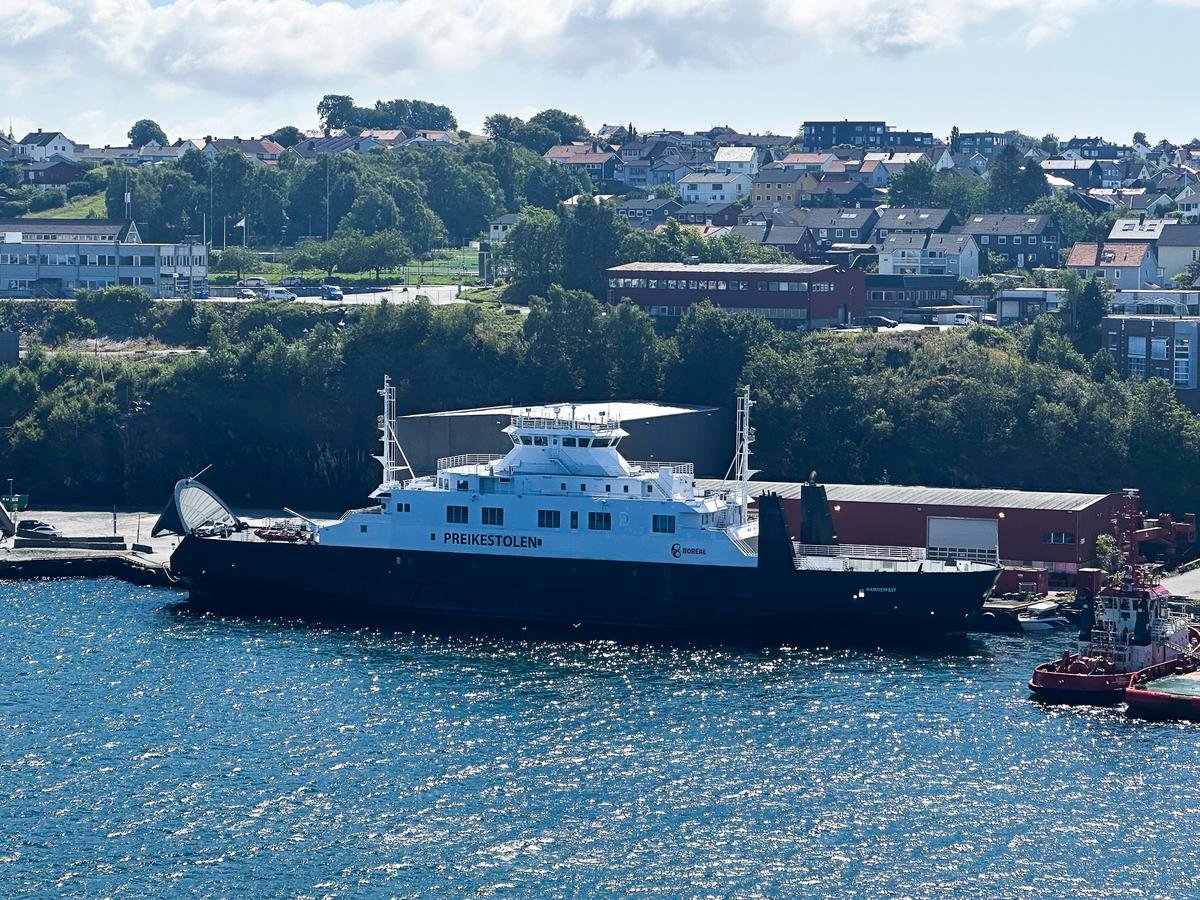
[{"x1": 1100, "y1": 314, "x2": 1200, "y2": 412}]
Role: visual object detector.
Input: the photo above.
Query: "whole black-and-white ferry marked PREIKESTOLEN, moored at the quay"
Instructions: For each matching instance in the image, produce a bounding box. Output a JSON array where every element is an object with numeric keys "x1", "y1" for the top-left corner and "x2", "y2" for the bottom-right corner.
[{"x1": 155, "y1": 379, "x2": 1000, "y2": 638}]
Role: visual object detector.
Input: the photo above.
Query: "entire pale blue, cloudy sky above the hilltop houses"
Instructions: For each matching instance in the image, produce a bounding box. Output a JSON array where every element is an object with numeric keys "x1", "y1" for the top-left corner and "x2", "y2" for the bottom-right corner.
[{"x1": 0, "y1": 0, "x2": 1200, "y2": 145}]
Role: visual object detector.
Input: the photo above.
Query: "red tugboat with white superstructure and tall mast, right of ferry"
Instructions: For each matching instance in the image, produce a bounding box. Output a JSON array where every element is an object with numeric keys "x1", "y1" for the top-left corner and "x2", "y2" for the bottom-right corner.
[{"x1": 1030, "y1": 490, "x2": 1200, "y2": 706}]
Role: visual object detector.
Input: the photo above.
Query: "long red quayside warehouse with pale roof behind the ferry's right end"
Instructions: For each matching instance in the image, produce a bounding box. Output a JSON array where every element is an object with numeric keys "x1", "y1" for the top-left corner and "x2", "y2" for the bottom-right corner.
[{"x1": 704, "y1": 481, "x2": 1195, "y2": 587}]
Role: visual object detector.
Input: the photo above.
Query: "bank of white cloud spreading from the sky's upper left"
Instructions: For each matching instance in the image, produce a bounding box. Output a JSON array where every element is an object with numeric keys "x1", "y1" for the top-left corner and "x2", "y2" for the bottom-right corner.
[{"x1": 0, "y1": 0, "x2": 1142, "y2": 142}]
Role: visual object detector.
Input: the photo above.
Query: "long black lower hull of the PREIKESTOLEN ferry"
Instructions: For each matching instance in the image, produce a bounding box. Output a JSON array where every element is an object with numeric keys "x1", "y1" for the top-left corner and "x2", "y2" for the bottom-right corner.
[{"x1": 170, "y1": 536, "x2": 997, "y2": 638}]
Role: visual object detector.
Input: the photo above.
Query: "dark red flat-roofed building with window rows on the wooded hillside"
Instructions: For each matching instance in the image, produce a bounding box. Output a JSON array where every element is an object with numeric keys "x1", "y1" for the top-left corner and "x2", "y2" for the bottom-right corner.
[{"x1": 607, "y1": 263, "x2": 866, "y2": 329}]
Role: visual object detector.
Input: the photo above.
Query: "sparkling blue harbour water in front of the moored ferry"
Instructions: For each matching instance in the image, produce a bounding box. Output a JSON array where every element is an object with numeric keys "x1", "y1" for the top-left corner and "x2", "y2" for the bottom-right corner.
[{"x1": 0, "y1": 581, "x2": 1200, "y2": 898}]
